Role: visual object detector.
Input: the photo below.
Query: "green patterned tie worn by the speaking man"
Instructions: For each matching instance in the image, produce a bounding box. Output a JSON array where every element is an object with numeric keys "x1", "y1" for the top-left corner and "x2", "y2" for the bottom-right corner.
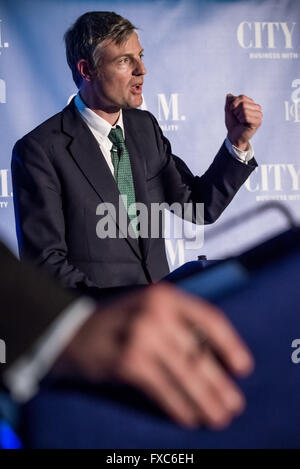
[{"x1": 108, "y1": 126, "x2": 138, "y2": 236}]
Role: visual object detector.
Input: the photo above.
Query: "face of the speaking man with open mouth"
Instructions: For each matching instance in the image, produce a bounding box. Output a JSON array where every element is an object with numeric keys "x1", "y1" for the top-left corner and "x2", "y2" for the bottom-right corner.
[{"x1": 91, "y1": 32, "x2": 146, "y2": 110}]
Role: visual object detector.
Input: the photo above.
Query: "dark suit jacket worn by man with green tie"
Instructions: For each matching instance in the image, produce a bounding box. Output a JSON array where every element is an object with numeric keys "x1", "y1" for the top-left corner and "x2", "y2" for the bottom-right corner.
[{"x1": 12, "y1": 101, "x2": 256, "y2": 291}]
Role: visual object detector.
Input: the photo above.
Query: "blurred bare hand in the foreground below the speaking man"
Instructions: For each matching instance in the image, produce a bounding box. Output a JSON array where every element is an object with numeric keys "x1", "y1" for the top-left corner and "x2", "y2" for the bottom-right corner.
[{"x1": 56, "y1": 284, "x2": 253, "y2": 428}]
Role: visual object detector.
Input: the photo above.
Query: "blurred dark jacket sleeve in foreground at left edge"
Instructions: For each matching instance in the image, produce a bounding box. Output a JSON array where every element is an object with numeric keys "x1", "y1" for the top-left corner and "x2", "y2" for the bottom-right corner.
[{"x1": 0, "y1": 242, "x2": 77, "y2": 378}]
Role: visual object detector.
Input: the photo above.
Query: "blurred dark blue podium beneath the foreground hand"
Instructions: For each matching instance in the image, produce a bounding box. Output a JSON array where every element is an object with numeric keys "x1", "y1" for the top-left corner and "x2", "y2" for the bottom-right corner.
[{"x1": 23, "y1": 229, "x2": 300, "y2": 449}]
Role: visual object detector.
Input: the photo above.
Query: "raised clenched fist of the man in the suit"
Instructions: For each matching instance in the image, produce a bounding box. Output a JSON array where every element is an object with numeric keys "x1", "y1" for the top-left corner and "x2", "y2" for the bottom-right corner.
[{"x1": 225, "y1": 94, "x2": 263, "y2": 150}]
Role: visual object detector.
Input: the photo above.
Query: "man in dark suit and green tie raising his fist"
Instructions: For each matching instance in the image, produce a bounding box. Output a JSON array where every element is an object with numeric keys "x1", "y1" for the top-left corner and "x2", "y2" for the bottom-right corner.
[{"x1": 12, "y1": 12, "x2": 261, "y2": 292}]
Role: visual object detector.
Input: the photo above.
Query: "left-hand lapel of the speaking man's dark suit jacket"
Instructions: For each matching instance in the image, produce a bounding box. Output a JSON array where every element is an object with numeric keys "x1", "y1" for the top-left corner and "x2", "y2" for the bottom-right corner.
[{"x1": 62, "y1": 101, "x2": 141, "y2": 257}]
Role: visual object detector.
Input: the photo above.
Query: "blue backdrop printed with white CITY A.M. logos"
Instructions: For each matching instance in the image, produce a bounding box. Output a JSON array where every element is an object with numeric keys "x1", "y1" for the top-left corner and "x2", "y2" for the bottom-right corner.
[{"x1": 0, "y1": 0, "x2": 300, "y2": 269}]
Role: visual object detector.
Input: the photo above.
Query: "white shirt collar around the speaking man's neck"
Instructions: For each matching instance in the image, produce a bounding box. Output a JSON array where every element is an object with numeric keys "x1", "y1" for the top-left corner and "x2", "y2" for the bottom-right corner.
[{"x1": 74, "y1": 93, "x2": 125, "y2": 139}]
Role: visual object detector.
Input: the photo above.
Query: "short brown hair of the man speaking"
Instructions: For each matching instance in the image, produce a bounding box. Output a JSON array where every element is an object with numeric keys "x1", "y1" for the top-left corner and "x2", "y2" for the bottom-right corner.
[{"x1": 64, "y1": 11, "x2": 136, "y2": 88}]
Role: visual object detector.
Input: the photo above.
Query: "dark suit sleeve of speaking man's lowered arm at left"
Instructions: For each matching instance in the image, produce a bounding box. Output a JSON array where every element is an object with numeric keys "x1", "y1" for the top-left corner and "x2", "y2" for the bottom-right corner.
[{"x1": 12, "y1": 136, "x2": 98, "y2": 296}]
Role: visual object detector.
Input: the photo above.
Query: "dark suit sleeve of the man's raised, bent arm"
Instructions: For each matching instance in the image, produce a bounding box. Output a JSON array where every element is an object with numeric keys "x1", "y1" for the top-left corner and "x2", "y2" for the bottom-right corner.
[{"x1": 148, "y1": 113, "x2": 257, "y2": 223}]
